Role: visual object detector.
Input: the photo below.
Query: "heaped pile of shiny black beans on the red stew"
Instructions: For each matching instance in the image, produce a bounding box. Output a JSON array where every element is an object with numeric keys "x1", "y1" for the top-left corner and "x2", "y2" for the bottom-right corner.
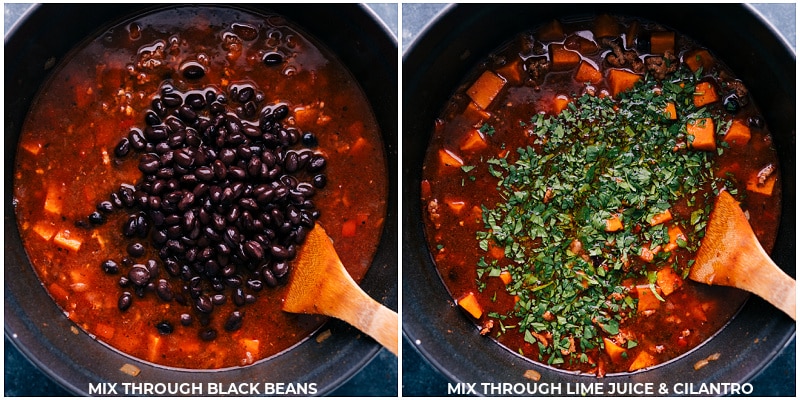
[{"x1": 88, "y1": 84, "x2": 326, "y2": 340}]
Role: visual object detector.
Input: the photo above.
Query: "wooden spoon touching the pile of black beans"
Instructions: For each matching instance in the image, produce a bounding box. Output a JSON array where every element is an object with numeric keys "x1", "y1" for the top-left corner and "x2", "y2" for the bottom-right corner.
[{"x1": 283, "y1": 224, "x2": 398, "y2": 355}]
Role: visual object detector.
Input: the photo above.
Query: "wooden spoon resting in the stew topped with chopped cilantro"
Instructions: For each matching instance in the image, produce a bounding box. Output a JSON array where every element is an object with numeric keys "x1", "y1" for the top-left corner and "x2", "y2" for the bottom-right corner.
[{"x1": 689, "y1": 191, "x2": 797, "y2": 320}]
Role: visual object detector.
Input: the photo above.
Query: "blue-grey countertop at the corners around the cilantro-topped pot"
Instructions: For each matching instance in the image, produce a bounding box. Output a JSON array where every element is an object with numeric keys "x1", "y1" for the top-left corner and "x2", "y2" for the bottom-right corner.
[{"x1": 401, "y1": 3, "x2": 797, "y2": 397}]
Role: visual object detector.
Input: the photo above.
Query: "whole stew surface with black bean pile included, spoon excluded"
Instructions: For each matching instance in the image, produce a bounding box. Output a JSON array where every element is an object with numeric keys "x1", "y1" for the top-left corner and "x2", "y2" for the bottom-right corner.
[{"x1": 14, "y1": 6, "x2": 388, "y2": 369}]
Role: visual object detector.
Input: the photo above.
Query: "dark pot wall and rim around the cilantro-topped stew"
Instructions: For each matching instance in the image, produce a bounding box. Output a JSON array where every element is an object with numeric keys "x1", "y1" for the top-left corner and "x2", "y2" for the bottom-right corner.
[{"x1": 402, "y1": 4, "x2": 796, "y2": 395}]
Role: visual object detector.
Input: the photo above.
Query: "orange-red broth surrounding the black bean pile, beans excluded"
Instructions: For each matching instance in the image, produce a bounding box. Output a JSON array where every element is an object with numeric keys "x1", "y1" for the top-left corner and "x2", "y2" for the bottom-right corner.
[{"x1": 14, "y1": 6, "x2": 388, "y2": 369}]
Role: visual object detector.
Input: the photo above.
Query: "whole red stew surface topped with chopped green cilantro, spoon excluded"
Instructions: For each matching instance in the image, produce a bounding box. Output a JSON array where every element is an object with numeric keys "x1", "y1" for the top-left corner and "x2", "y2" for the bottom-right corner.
[{"x1": 421, "y1": 15, "x2": 780, "y2": 376}]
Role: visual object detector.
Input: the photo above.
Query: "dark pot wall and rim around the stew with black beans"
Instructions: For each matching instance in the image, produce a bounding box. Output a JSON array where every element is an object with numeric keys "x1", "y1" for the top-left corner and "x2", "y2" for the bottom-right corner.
[{"x1": 4, "y1": 4, "x2": 398, "y2": 394}]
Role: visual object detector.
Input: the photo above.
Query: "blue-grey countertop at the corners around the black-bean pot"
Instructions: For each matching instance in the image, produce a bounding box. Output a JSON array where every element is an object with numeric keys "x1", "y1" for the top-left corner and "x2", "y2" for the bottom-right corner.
[{"x1": 4, "y1": 3, "x2": 398, "y2": 397}]
